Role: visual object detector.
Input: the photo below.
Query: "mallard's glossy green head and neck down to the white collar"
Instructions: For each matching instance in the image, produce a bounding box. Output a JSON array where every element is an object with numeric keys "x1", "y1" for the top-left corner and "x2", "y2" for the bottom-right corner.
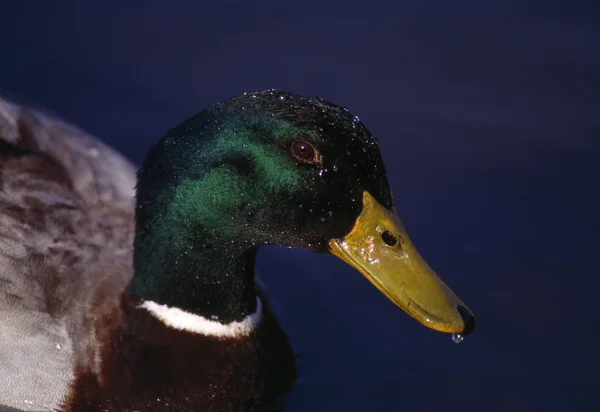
[{"x1": 130, "y1": 91, "x2": 474, "y2": 334}]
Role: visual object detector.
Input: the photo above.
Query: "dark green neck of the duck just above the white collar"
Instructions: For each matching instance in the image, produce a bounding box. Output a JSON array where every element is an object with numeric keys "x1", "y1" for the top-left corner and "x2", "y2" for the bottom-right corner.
[{"x1": 129, "y1": 222, "x2": 256, "y2": 324}]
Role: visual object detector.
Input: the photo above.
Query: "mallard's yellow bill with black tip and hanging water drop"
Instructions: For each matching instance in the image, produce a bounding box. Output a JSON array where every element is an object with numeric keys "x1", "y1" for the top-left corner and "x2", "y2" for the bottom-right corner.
[{"x1": 329, "y1": 192, "x2": 475, "y2": 335}]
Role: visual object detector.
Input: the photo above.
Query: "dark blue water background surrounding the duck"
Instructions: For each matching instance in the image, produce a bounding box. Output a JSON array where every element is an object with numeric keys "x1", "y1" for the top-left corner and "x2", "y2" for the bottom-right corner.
[{"x1": 0, "y1": 0, "x2": 600, "y2": 412}]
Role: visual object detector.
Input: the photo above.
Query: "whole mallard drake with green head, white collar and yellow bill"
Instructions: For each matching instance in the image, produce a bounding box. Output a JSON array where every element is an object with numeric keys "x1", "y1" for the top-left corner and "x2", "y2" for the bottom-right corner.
[{"x1": 0, "y1": 90, "x2": 475, "y2": 412}]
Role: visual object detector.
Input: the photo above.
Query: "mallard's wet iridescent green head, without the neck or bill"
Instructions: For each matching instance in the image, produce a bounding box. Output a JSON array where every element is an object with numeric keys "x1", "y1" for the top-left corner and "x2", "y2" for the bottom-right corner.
[{"x1": 137, "y1": 91, "x2": 391, "y2": 251}]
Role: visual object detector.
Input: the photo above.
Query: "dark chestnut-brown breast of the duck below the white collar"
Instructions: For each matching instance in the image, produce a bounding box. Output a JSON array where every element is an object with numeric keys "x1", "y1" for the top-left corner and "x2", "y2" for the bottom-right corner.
[{"x1": 65, "y1": 303, "x2": 295, "y2": 412}]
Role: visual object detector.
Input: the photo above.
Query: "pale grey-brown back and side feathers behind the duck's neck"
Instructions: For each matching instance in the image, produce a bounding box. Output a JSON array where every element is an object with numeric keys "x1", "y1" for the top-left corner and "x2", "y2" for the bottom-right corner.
[{"x1": 0, "y1": 97, "x2": 135, "y2": 411}]
